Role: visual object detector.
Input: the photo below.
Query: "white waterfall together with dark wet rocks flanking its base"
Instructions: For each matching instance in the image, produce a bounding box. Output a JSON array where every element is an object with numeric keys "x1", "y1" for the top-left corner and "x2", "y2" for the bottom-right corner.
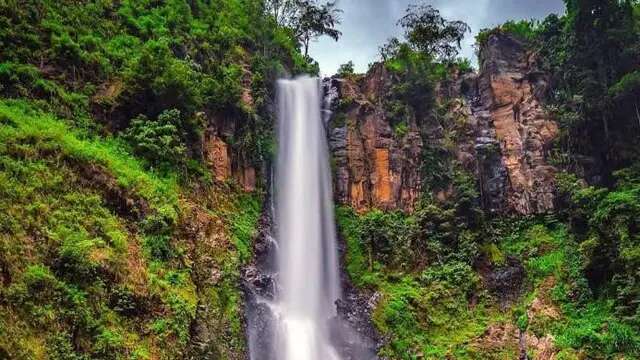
[{"x1": 243, "y1": 77, "x2": 377, "y2": 360}]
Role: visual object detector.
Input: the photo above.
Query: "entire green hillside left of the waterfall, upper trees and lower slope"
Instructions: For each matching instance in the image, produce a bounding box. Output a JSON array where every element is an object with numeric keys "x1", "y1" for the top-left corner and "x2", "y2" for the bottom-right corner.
[{"x1": 0, "y1": 0, "x2": 316, "y2": 359}]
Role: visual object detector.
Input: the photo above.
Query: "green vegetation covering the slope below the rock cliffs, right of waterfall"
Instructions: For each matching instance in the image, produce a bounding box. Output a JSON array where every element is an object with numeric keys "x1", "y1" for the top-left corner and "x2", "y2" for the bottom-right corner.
[{"x1": 336, "y1": 208, "x2": 640, "y2": 359}]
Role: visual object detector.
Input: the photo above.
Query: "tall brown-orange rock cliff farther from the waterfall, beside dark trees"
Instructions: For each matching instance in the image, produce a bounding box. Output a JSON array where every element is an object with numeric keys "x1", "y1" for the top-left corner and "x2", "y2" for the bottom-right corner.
[{"x1": 472, "y1": 34, "x2": 558, "y2": 214}]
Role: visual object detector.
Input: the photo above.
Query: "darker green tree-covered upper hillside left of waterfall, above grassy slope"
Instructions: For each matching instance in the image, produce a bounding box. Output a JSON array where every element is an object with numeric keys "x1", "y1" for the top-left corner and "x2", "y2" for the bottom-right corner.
[{"x1": 0, "y1": 0, "x2": 317, "y2": 170}]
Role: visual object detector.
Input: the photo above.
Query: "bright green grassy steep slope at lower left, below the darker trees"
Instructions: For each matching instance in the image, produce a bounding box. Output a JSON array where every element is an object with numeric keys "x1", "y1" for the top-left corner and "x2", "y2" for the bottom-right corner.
[{"x1": 0, "y1": 101, "x2": 259, "y2": 359}]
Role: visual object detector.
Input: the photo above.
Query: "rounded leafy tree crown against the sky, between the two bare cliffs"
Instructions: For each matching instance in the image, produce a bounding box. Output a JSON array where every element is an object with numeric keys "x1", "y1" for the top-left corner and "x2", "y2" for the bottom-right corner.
[{"x1": 398, "y1": 4, "x2": 471, "y2": 61}]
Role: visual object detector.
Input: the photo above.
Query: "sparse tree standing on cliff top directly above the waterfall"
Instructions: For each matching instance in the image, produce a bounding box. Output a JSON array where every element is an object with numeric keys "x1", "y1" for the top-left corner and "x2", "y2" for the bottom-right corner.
[{"x1": 265, "y1": 0, "x2": 342, "y2": 57}]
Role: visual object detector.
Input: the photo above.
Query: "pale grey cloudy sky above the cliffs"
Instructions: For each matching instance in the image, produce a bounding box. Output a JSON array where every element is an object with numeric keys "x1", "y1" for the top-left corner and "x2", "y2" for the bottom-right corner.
[{"x1": 310, "y1": 0, "x2": 564, "y2": 75}]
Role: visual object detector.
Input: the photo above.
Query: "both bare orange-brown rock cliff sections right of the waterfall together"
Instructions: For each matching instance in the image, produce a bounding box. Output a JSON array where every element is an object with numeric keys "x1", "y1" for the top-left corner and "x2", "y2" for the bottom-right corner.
[{"x1": 330, "y1": 34, "x2": 558, "y2": 215}]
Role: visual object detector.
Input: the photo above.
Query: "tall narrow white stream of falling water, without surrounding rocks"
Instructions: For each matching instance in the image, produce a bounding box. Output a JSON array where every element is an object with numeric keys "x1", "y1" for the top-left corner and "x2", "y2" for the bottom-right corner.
[{"x1": 274, "y1": 77, "x2": 340, "y2": 360}]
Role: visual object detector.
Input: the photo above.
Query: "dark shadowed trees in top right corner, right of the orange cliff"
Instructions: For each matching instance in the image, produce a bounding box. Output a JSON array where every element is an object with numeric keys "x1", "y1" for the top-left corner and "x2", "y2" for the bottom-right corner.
[{"x1": 541, "y1": 0, "x2": 640, "y2": 166}]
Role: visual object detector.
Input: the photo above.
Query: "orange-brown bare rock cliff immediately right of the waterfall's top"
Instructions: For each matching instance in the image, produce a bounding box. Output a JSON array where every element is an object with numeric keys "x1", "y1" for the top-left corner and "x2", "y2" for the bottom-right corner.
[{"x1": 329, "y1": 64, "x2": 422, "y2": 211}]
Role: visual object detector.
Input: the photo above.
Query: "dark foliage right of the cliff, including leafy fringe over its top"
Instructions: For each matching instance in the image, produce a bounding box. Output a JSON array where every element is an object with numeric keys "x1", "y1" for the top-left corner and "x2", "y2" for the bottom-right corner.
[{"x1": 477, "y1": 0, "x2": 640, "y2": 177}]
